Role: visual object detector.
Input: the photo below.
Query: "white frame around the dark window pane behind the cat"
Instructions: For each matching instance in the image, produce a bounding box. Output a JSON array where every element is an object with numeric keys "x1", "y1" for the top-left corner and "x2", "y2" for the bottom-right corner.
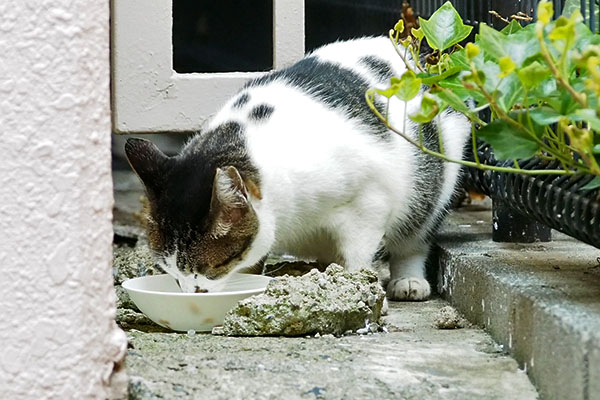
[{"x1": 112, "y1": 0, "x2": 304, "y2": 133}]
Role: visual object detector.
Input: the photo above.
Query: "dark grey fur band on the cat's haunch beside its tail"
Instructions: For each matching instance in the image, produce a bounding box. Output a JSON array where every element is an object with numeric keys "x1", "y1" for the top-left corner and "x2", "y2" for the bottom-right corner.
[{"x1": 395, "y1": 122, "x2": 444, "y2": 240}]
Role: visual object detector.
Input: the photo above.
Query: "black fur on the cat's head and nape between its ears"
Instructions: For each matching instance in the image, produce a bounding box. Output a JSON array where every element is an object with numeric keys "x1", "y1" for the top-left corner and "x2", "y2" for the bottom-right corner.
[{"x1": 155, "y1": 122, "x2": 259, "y2": 247}]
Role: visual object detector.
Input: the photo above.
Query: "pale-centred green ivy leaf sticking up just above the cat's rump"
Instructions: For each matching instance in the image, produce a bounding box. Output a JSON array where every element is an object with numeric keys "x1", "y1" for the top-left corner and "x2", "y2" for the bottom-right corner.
[{"x1": 419, "y1": 1, "x2": 473, "y2": 51}]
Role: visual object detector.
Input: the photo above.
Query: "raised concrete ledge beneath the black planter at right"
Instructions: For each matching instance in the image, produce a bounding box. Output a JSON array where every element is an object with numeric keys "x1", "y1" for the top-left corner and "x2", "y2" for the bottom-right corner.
[{"x1": 438, "y1": 207, "x2": 600, "y2": 400}]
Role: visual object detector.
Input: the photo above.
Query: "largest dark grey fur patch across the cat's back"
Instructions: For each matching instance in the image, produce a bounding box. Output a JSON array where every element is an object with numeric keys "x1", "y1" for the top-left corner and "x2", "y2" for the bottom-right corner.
[{"x1": 245, "y1": 57, "x2": 391, "y2": 138}]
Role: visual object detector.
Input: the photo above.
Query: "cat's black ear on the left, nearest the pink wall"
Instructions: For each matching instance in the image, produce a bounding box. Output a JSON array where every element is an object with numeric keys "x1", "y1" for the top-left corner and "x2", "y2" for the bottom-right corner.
[{"x1": 125, "y1": 138, "x2": 169, "y2": 190}]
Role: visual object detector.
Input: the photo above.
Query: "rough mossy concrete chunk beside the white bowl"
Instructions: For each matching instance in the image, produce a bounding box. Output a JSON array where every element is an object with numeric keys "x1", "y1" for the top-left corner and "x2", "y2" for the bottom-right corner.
[{"x1": 220, "y1": 264, "x2": 385, "y2": 336}]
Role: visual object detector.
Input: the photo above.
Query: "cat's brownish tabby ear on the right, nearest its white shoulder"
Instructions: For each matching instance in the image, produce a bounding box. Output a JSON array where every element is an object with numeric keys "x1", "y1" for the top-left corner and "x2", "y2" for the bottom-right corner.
[{"x1": 210, "y1": 167, "x2": 250, "y2": 237}]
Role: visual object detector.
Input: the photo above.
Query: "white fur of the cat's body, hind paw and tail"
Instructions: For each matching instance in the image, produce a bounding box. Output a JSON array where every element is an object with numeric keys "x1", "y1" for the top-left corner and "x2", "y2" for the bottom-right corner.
[{"x1": 209, "y1": 38, "x2": 470, "y2": 300}]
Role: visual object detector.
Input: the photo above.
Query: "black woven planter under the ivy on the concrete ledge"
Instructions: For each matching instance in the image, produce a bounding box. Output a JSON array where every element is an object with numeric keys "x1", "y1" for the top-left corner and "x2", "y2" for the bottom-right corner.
[{"x1": 465, "y1": 146, "x2": 600, "y2": 248}]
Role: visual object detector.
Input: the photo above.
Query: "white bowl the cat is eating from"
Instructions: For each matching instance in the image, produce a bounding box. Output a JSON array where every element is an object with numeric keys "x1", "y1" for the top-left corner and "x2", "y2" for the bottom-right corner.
[{"x1": 121, "y1": 274, "x2": 271, "y2": 332}]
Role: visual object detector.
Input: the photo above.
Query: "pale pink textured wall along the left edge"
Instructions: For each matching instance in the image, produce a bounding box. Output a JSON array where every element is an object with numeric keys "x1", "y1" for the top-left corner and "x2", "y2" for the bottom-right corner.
[{"x1": 0, "y1": 0, "x2": 126, "y2": 399}]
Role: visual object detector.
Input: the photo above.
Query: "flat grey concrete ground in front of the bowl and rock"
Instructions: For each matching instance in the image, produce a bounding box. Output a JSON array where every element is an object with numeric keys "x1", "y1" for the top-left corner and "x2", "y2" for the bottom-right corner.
[{"x1": 126, "y1": 298, "x2": 537, "y2": 400}]
